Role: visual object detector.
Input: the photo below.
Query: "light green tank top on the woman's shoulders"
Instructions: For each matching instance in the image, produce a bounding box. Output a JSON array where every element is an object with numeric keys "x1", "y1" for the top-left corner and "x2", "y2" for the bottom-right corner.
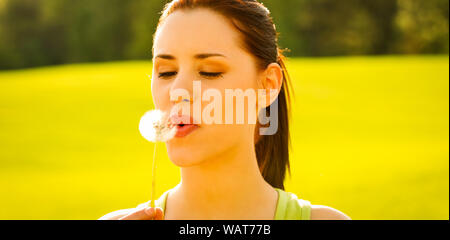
[{"x1": 138, "y1": 188, "x2": 311, "y2": 220}]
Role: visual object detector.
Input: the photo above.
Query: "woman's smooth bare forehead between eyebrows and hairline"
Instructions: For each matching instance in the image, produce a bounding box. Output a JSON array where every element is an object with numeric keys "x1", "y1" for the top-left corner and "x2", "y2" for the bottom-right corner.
[{"x1": 153, "y1": 9, "x2": 242, "y2": 56}]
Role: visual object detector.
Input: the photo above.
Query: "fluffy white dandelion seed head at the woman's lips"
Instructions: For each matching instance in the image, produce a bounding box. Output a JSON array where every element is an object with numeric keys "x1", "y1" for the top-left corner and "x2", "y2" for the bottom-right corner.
[{"x1": 139, "y1": 110, "x2": 177, "y2": 142}]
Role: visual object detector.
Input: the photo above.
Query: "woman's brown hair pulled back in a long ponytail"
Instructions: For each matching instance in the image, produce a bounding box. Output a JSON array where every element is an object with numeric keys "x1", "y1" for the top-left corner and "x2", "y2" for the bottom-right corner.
[{"x1": 158, "y1": 0, "x2": 290, "y2": 190}]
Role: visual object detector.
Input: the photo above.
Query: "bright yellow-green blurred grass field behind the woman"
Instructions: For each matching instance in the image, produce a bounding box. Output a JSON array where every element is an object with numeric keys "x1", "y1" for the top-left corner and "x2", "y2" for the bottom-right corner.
[{"x1": 0, "y1": 56, "x2": 449, "y2": 219}]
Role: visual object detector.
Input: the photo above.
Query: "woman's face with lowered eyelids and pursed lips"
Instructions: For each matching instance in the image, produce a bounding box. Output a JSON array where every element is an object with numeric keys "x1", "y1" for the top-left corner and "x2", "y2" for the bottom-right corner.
[{"x1": 152, "y1": 9, "x2": 260, "y2": 167}]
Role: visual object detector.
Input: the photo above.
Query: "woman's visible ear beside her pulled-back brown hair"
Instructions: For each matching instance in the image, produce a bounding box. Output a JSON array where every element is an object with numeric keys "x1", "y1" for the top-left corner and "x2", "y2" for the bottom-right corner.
[{"x1": 258, "y1": 63, "x2": 283, "y2": 108}]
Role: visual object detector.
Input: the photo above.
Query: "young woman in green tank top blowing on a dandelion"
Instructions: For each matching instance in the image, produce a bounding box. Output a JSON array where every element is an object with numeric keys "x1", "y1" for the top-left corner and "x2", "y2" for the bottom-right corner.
[{"x1": 100, "y1": 0, "x2": 349, "y2": 220}]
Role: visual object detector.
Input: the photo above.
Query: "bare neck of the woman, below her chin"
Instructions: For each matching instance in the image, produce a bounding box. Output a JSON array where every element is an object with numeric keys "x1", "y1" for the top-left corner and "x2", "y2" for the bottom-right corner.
[{"x1": 171, "y1": 139, "x2": 276, "y2": 216}]
